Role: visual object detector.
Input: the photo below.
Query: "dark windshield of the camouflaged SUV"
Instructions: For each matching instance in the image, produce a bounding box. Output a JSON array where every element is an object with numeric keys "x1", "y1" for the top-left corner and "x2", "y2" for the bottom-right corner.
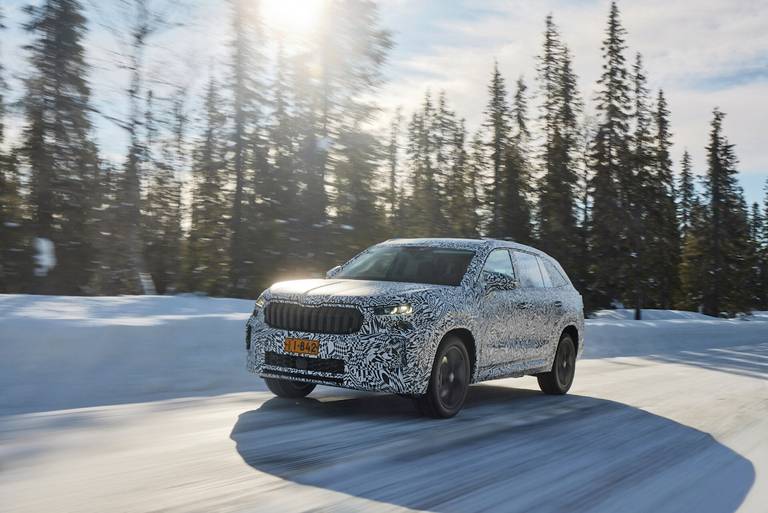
[{"x1": 334, "y1": 246, "x2": 475, "y2": 286}]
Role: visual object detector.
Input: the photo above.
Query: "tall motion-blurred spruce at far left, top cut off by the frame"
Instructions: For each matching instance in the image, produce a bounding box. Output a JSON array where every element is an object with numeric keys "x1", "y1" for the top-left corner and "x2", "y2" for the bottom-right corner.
[{"x1": 22, "y1": 0, "x2": 99, "y2": 294}]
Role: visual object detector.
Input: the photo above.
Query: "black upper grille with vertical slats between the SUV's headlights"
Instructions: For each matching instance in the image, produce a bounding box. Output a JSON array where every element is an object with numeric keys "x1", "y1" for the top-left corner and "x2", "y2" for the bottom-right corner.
[{"x1": 264, "y1": 301, "x2": 363, "y2": 335}]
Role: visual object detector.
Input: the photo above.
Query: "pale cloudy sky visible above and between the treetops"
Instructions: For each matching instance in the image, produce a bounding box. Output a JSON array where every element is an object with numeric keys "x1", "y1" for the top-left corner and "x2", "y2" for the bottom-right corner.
[{"x1": 0, "y1": 0, "x2": 768, "y2": 206}]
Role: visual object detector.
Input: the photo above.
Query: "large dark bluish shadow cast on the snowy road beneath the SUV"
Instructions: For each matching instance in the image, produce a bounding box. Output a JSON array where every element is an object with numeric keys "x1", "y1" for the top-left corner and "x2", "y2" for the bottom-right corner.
[{"x1": 231, "y1": 385, "x2": 755, "y2": 513}]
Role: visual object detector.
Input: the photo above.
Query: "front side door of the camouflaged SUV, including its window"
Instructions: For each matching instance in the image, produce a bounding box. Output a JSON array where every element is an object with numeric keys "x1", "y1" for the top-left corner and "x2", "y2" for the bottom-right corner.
[{"x1": 478, "y1": 248, "x2": 522, "y2": 367}]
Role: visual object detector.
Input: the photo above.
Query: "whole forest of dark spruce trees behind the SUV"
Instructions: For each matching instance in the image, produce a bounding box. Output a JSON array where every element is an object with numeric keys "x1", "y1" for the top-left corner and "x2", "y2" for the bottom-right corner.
[{"x1": 0, "y1": 0, "x2": 768, "y2": 315}]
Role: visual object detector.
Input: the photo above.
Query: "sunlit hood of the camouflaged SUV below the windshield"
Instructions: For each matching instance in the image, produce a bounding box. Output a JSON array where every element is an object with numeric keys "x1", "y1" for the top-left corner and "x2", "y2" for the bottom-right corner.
[{"x1": 269, "y1": 279, "x2": 446, "y2": 299}]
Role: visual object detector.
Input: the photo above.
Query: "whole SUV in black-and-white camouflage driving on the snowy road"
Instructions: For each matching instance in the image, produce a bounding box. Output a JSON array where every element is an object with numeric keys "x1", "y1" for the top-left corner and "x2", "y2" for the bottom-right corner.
[{"x1": 246, "y1": 239, "x2": 584, "y2": 417}]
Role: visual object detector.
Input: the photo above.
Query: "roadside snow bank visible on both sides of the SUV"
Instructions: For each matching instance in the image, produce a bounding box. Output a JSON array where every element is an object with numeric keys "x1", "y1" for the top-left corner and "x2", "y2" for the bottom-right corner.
[{"x1": 0, "y1": 295, "x2": 768, "y2": 414}]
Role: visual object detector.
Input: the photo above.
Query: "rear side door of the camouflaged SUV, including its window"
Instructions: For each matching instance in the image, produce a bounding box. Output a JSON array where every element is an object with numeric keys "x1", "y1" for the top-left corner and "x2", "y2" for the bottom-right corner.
[{"x1": 512, "y1": 250, "x2": 551, "y2": 361}]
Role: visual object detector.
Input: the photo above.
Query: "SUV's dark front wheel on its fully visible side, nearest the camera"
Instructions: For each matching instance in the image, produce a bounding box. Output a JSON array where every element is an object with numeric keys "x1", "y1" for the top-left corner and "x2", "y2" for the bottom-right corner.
[{"x1": 414, "y1": 336, "x2": 470, "y2": 418}]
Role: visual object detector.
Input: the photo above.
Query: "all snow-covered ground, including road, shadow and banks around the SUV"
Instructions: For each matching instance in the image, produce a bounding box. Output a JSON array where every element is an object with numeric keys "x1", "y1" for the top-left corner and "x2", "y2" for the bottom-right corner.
[{"x1": 0, "y1": 295, "x2": 768, "y2": 513}]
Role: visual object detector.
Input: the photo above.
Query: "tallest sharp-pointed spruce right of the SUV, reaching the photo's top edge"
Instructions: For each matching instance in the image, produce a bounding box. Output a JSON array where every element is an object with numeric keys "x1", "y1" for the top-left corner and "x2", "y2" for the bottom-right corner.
[{"x1": 589, "y1": 2, "x2": 632, "y2": 306}]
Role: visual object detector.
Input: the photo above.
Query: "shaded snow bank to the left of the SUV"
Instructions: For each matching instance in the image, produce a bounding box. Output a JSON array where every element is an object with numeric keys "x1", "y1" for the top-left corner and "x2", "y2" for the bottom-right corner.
[{"x1": 0, "y1": 295, "x2": 262, "y2": 413}]
